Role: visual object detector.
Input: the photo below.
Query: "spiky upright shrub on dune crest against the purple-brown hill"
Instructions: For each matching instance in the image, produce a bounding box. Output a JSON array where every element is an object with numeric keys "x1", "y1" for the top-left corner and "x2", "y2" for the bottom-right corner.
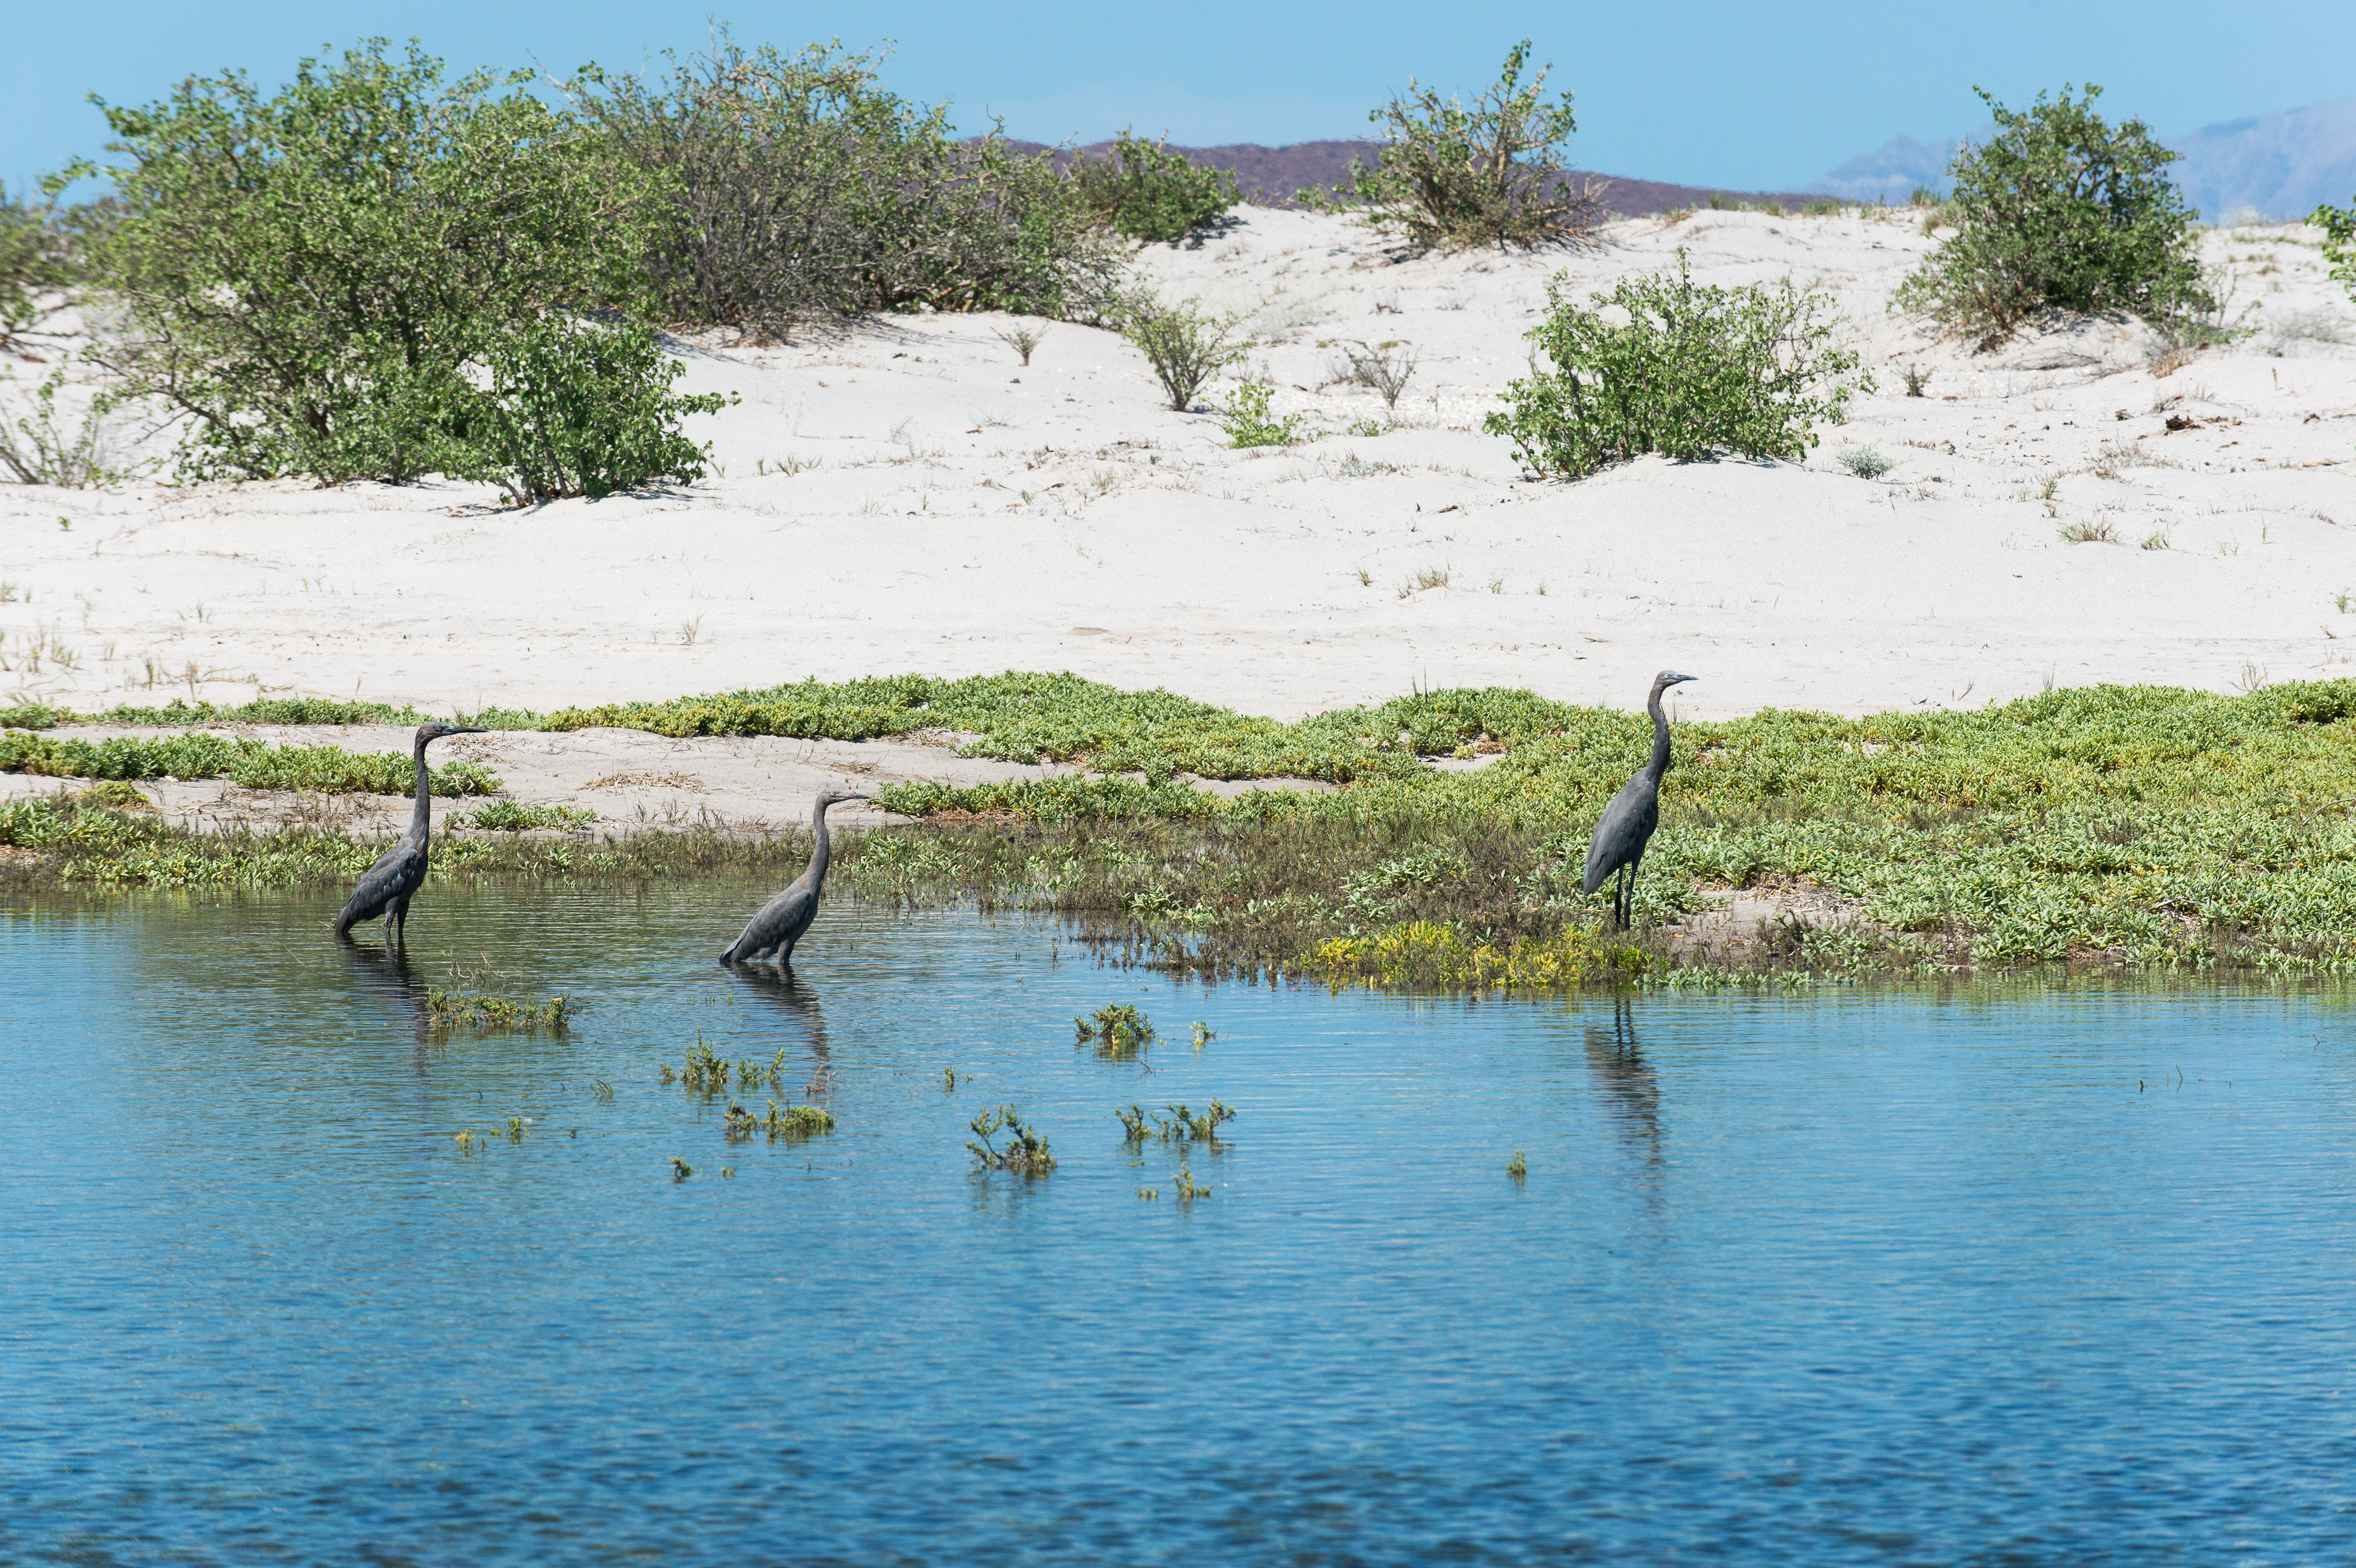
[{"x1": 1303, "y1": 38, "x2": 1604, "y2": 250}]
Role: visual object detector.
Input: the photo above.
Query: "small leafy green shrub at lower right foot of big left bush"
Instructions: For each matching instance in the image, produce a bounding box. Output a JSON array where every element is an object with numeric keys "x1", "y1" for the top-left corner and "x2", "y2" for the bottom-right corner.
[{"x1": 452, "y1": 313, "x2": 735, "y2": 506}]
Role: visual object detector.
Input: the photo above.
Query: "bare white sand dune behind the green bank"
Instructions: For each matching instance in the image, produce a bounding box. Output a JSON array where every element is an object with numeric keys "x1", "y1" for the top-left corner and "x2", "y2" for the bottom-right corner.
[{"x1": 0, "y1": 209, "x2": 2356, "y2": 716}]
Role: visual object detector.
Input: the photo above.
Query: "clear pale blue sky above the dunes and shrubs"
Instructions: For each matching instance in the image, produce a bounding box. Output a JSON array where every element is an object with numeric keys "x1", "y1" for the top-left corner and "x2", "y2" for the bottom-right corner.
[{"x1": 0, "y1": 0, "x2": 2356, "y2": 188}]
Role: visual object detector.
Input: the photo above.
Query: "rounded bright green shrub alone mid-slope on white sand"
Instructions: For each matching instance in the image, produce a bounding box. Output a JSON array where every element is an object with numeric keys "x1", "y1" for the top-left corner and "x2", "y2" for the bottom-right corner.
[{"x1": 1482, "y1": 250, "x2": 1873, "y2": 478}]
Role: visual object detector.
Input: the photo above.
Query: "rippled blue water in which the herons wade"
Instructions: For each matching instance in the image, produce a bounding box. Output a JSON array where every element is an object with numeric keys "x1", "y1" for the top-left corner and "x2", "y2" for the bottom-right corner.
[{"x1": 0, "y1": 885, "x2": 2356, "y2": 1563}]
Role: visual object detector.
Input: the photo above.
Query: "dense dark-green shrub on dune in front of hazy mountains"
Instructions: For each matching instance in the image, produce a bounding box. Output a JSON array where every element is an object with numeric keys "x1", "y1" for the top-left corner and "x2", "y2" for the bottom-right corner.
[{"x1": 1892, "y1": 85, "x2": 2219, "y2": 339}]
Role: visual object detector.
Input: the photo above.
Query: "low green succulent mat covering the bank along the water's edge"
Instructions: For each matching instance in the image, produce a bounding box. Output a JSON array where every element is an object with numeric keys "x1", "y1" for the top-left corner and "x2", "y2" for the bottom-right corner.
[{"x1": 13, "y1": 675, "x2": 2356, "y2": 987}]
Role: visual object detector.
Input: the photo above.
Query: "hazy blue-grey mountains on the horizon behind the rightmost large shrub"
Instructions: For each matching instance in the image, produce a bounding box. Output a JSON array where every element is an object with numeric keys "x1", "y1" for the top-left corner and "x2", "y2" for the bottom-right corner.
[{"x1": 1810, "y1": 99, "x2": 2356, "y2": 224}]
